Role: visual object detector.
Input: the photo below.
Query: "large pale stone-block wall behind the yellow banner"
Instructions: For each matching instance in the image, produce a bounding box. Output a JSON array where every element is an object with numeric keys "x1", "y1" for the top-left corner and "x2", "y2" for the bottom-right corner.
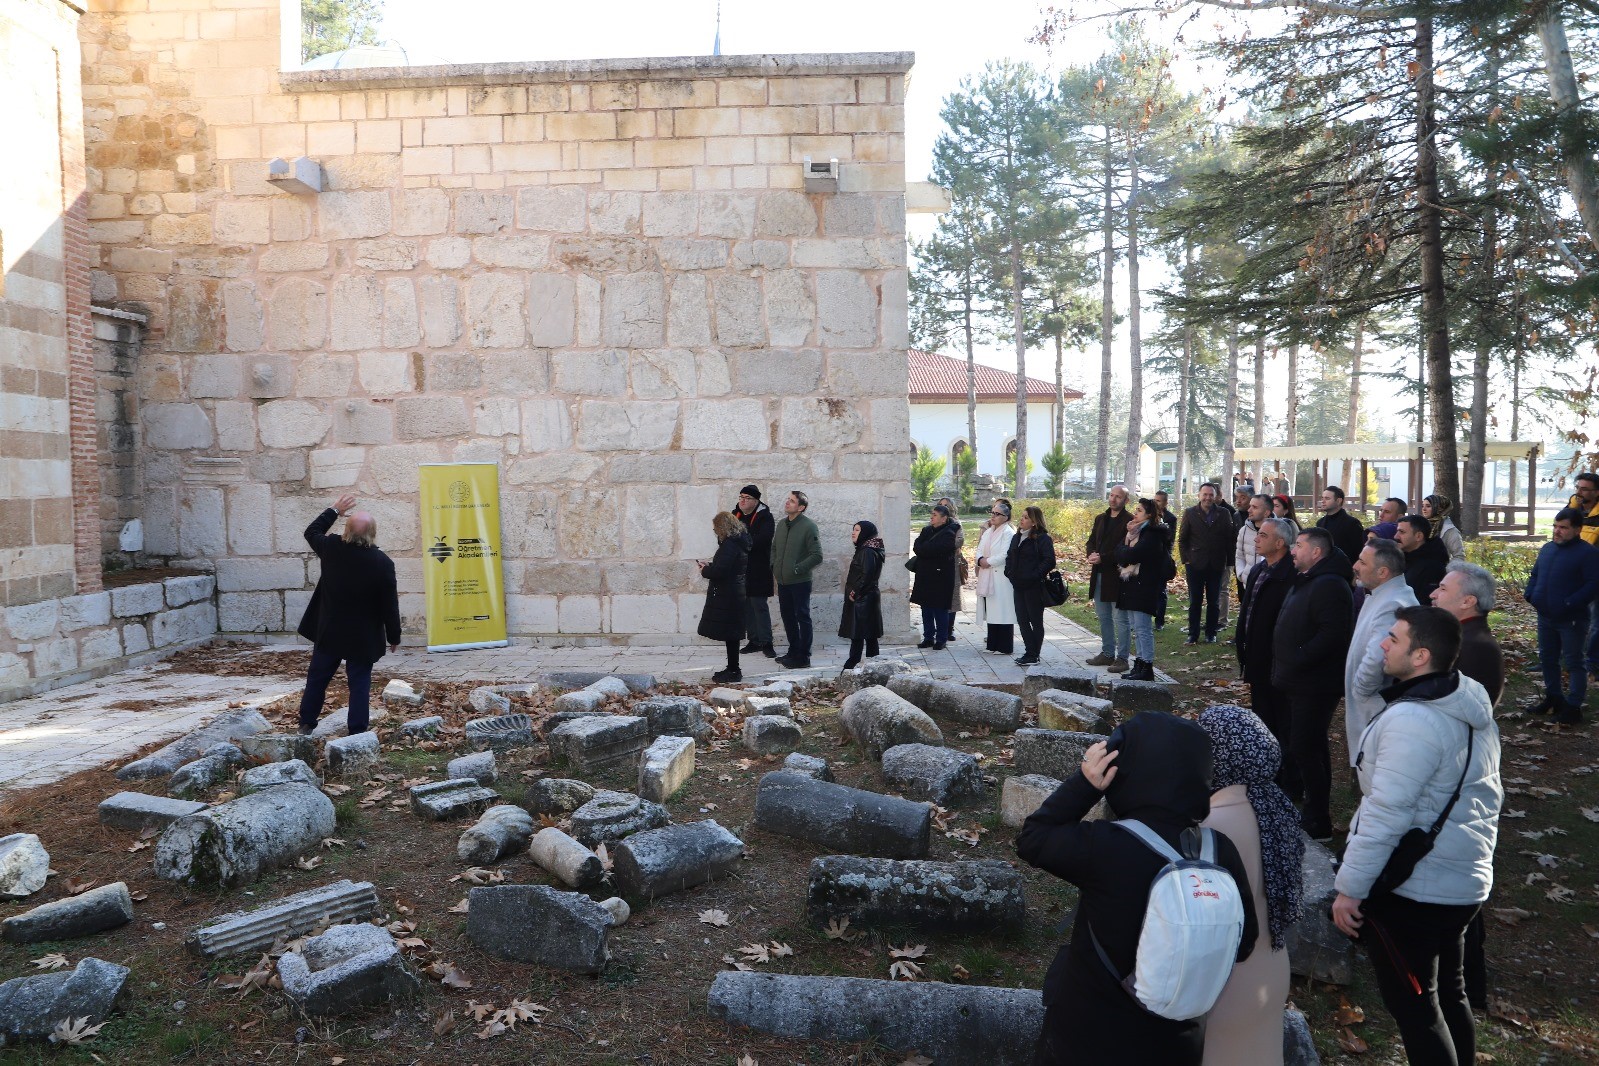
[{"x1": 85, "y1": 0, "x2": 910, "y2": 642}]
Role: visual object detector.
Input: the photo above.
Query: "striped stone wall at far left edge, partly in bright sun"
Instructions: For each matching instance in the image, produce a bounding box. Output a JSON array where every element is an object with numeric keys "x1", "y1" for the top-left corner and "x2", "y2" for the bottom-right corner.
[{"x1": 0, "y1": 0, "x2": 99, "y2": 606}]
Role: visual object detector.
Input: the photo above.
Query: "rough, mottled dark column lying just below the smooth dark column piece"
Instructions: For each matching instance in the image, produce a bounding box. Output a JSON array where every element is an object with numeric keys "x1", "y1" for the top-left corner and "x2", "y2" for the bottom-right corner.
[{"x1": 806, "y1": 855, "x2": 1027, "y2": 933}]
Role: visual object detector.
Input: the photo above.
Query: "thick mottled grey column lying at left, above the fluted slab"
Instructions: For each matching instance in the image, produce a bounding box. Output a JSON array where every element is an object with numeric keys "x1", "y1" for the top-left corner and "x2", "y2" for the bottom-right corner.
[{"x1": 155, "y1": 785, "x2": 334, "y2": 889}]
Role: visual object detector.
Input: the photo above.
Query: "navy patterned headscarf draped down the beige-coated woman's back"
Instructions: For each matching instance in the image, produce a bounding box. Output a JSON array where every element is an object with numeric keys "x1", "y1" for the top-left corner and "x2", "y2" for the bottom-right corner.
[{"x1": 1199, "y1": 705, "x2": 1305, "y2": 951}]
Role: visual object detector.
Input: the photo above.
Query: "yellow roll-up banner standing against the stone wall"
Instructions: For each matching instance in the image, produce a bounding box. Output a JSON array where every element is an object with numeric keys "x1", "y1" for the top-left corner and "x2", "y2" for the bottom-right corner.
[{"x1": 417, "y1": 463, "x2": 507, "y2": 652}]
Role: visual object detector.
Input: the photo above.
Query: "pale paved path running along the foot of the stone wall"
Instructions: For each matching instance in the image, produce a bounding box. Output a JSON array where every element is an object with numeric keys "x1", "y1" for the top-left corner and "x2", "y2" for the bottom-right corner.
[{"x1": 0, "y1": 600, "x2": 1169, "y2": 790}]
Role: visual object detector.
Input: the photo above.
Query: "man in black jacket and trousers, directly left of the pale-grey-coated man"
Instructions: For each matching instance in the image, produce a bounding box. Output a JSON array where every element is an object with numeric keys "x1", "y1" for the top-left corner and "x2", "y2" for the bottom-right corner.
[{"x1": 1271, "y1": 529, "x2": 1354, "y2": 842}]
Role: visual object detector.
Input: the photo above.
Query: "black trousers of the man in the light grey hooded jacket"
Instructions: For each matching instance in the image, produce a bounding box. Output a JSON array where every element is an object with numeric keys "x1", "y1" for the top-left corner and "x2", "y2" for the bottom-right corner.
[{"x1": 1361, "y1": 895, "x2": 1481, "y2": 1066}]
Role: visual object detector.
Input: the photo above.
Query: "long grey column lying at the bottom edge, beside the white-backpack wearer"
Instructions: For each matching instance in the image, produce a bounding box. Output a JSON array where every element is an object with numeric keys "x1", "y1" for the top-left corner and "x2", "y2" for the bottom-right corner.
[{"x1": 710, "y1": 970, "x2": 1044, "y2": 1066}]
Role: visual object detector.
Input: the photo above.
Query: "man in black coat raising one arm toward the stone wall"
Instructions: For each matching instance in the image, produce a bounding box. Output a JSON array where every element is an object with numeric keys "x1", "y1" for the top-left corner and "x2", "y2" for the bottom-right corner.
[{"x1": 299, "y1": 495, "x2": 400, "y2": 735}]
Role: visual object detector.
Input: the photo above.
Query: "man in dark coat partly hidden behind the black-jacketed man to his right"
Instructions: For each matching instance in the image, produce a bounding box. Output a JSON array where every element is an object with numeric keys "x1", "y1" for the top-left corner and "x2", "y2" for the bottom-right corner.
[{"x1": 1236, "y1": 518, "x2": 1303, "y2": 799}]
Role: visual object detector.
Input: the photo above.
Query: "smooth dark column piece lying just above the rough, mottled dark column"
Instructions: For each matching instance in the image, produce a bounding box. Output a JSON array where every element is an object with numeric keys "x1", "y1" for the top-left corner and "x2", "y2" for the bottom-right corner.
[{"x1": 755, "y1": 770, "x2": 932, "y2": 858}]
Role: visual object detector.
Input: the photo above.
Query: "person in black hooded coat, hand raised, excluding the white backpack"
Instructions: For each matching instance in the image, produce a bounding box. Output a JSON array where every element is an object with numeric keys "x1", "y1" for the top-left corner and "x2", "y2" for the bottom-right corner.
[{"x1": 1015, "y1": 714, "x2": 1253, "y2": 1066}]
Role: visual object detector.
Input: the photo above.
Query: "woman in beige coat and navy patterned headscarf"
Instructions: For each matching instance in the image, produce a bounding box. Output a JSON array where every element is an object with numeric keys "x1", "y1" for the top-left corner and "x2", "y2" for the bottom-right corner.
[{"x1": 1199, "y1": 706, "x2": 1305, "y2": 1066}]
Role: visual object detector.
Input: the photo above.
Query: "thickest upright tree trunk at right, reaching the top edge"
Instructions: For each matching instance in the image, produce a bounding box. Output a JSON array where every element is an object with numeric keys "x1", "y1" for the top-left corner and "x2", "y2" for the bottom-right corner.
[{"x1": 1415, "y1": 16, "x2": 1460, "y2": 503}]
